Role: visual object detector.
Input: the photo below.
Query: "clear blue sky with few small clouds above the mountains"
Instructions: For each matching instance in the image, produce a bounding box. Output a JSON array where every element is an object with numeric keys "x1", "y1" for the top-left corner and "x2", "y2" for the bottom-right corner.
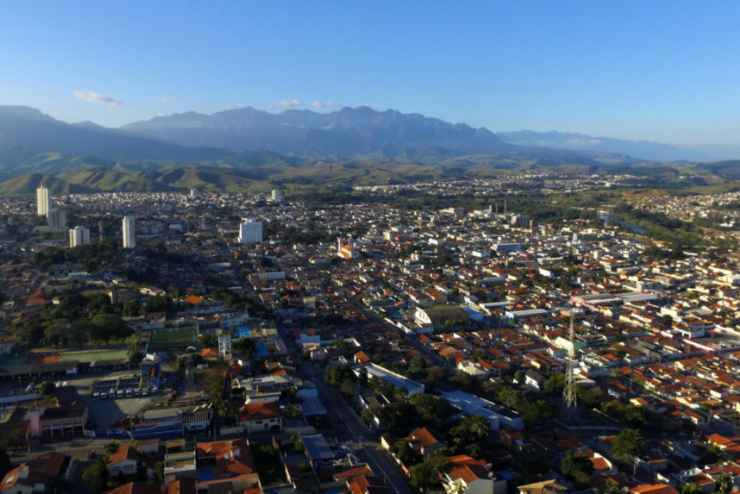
[{"x1": 0, "y1": 0, "x2": 740, "y2": 146}]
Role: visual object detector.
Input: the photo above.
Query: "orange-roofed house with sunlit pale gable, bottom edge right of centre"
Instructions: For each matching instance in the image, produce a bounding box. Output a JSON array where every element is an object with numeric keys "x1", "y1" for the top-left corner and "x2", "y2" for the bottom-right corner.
[{"x1": 440, "y1": 455, "x2": 507, "y2": 494}]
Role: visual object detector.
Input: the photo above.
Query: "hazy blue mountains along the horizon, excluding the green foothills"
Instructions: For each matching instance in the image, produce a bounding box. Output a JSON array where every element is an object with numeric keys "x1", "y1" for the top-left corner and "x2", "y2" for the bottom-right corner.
[{"x1": 0, "y1": 106, "x2": 723, "y2": 168}]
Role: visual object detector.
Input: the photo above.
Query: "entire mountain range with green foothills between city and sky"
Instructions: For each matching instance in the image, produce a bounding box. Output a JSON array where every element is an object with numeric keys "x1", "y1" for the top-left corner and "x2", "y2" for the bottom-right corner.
[{"x1": 0, "y1": 106, "x2": 740, "y2": 194}]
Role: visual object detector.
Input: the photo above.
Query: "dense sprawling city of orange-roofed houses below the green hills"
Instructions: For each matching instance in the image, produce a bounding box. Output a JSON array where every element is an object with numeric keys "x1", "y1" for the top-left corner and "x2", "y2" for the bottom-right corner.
[{"x1": 0, "y1": 173, "x2": 740, "y2": 494}]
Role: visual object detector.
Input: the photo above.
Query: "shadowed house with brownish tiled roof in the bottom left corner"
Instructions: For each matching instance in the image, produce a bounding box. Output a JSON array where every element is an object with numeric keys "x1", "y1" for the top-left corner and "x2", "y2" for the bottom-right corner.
[{"x1": 0, "y1": 453, "x2": 67, "y2": 494}]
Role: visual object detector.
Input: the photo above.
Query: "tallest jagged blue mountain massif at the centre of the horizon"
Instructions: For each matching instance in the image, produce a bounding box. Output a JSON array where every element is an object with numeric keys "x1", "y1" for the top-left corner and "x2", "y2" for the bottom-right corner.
[{"x1": 123, "y1": 106, "x2": 517, "y2": 159}]
